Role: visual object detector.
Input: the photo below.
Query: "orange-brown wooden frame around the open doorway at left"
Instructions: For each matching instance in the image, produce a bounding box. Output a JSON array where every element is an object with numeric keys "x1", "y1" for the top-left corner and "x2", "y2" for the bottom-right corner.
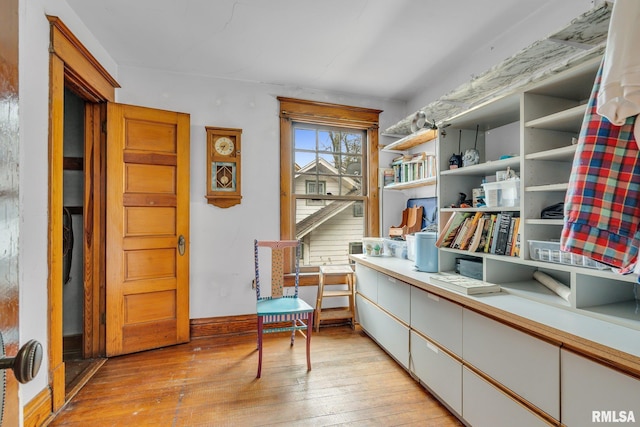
[{"x1": 47, "y1": 16, "x2": 120, "y2": 412}]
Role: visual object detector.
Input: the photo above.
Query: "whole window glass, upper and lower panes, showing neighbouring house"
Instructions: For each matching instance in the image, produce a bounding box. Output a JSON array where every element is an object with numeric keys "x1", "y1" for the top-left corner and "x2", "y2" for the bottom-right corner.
[{"x1": 292, "y1": 123, "x2": 367, "y2": 266}]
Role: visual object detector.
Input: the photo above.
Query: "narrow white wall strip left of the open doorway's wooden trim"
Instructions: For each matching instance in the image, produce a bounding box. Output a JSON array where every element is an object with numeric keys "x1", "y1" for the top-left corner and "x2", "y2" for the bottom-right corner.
[{"x1": 18, "y1": 0, "x2": 117, "y2": 405}]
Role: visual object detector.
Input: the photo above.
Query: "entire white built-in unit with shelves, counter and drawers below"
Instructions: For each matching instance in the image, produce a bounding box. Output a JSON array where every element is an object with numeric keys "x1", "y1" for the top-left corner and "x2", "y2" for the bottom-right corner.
[{"x1": 352, "y1": 4, "x2": 640, "y2": 425}]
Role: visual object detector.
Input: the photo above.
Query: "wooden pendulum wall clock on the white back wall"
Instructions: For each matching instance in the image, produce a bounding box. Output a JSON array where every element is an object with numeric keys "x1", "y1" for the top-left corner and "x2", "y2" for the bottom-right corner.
[{"x1": 205, "y1": 126, "x2": 242, "y2": 208}]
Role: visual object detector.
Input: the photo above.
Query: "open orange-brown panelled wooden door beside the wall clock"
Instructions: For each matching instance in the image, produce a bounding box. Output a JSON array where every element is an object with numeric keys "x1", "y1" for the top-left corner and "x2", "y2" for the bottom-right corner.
[{"x1": 106, "y1": 103, "x2": 190, "y2": 356}]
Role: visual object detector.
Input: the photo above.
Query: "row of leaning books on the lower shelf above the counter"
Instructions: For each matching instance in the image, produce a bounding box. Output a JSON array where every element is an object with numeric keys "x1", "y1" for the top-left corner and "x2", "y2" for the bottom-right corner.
[{"x1": 435, "y1": 211, "x2": 521, "y2": 256}]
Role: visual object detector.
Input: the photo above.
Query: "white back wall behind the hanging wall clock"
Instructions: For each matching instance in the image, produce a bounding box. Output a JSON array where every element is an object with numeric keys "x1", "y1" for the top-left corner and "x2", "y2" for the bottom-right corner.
[{"x1": 117, "y1": 67, "x2": 404, "y2": 318}]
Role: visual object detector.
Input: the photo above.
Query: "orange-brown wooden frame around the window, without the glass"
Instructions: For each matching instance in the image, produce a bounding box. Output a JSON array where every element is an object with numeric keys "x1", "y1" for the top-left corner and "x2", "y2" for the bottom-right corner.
[{"x1": 277, "y1": 96, "x2": 382, "y2": 278}]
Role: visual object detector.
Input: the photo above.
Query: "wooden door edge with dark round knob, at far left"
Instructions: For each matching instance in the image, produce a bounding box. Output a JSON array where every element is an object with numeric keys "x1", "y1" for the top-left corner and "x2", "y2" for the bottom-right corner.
[{"x1": 0, "y1": 0, "x2": 20, "y2": 426}]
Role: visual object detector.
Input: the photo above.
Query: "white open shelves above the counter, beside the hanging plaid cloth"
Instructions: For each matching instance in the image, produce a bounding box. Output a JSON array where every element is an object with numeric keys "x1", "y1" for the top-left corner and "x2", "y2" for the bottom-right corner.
[{"x1": 438, "y1": 52, "x2": 640, "y2": 330}]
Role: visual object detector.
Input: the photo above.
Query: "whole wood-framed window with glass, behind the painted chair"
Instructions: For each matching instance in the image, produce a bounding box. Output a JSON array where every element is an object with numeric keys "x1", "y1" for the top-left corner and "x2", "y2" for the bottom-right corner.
[{"x1": 278, "y1": 98, "x2": 380, "y2": 271}]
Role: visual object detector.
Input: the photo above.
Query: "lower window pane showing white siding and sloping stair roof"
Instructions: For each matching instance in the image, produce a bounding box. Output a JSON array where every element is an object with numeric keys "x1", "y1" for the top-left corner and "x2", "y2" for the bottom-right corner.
[{"x1": 296, "y1": 199, "x2": 365, "y2": 266}]
